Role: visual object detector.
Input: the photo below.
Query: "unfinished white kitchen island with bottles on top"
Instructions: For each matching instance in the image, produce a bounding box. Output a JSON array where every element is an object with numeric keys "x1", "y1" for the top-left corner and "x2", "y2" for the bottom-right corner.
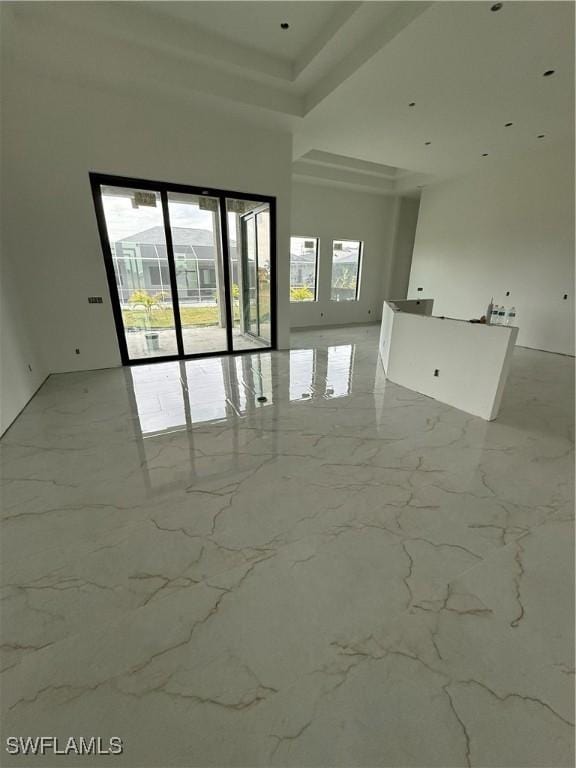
[{"x1": 380, "y1": 299, "x2": 518, "y2": 421}]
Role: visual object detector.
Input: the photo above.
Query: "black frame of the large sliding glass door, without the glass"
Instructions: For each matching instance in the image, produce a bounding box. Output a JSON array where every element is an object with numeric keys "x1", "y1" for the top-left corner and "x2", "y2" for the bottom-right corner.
[{"x1": 88, "y1": 171, "x2": 277, "y2": 365}]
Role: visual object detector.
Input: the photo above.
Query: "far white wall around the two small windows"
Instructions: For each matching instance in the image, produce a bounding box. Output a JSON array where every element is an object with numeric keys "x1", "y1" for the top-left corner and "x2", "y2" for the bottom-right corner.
[{"x1": 290, "y1": 181, "x2": 396, "y2": 328}]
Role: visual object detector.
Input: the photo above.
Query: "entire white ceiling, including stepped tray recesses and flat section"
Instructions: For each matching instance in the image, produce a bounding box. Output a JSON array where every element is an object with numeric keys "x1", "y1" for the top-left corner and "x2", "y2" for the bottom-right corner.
[{"x1": 2, "y1": 0, "x2": 574, "y2": 193}]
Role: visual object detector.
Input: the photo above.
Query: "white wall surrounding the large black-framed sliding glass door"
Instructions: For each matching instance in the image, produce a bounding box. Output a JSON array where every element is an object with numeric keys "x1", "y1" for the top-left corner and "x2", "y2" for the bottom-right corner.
[{"x1": 3, "y1": 13, "x2": 292, "y2": 380}]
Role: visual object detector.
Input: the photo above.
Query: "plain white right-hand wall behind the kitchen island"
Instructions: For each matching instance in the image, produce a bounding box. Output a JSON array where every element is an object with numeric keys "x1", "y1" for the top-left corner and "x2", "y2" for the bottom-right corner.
[{"x1": 408, "y1": 142, "x2": 574, "y2": 354}]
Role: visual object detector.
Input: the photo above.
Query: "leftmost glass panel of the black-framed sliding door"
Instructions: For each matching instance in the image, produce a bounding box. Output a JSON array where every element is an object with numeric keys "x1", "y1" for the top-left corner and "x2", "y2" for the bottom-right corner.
[{"x1": 100, "y1": 186, "x2": 178, "y2": 360}]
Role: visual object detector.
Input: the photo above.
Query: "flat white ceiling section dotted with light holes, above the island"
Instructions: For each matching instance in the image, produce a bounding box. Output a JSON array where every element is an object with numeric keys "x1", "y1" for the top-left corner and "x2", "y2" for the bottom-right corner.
[{"x1": 296, "y1": 2, "x2": 574, "y2": 184}]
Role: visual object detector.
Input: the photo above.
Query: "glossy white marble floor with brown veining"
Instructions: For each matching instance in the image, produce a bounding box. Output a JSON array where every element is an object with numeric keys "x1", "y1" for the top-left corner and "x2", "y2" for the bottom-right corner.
[{"x1": 0, "y1": 326, "x2": 574, "y2": 768}]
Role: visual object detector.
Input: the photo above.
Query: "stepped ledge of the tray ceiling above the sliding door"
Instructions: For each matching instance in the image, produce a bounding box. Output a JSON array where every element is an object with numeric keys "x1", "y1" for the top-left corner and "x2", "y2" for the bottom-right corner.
[{"x1": 5, "y1": 1, "x2": 431, "y2": 117}]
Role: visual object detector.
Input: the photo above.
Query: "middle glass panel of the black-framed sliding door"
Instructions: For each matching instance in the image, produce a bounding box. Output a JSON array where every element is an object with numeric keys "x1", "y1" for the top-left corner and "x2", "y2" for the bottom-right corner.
[{"x1": 168, "y1": 192, "x2": 228, "y2": 355}]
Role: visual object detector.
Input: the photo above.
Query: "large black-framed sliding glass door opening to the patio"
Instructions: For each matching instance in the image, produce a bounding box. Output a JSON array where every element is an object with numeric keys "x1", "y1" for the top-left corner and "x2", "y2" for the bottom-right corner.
[{"x1": 90, "y1": 174, "x2": 275, "y2": 363}]
